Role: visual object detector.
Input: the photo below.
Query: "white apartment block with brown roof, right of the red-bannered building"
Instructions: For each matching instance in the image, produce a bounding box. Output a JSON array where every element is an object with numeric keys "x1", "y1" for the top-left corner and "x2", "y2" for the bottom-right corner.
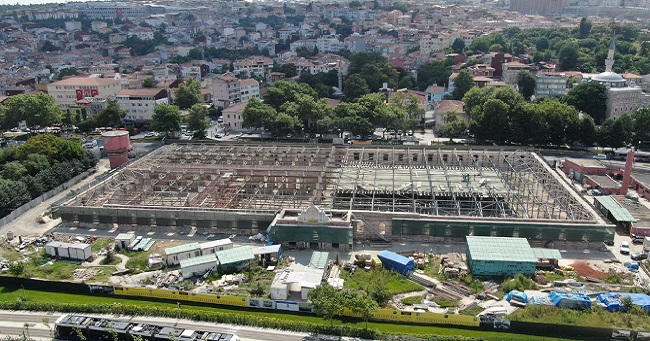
[{"x1": 117, "y1": 88, "x2": 169, "y2": 122}]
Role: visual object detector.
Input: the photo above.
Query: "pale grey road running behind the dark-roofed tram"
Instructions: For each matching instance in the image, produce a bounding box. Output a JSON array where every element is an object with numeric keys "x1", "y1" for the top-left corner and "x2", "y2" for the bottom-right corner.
[{"x1": 0, "y1": 310, "x2": 330, "y2": 341}]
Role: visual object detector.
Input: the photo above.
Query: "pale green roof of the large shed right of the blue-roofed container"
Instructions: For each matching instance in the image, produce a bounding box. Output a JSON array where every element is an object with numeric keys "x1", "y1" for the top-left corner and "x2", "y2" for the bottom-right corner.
[{"x1": 465, "y1": 236, "x2": 537, "y2": 263}]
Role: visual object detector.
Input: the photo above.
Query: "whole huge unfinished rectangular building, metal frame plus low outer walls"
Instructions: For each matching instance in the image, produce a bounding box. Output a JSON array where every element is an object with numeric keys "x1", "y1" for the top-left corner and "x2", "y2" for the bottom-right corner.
[{"x1": 53, "y1": 144, "x2": 615, "y2": 249}]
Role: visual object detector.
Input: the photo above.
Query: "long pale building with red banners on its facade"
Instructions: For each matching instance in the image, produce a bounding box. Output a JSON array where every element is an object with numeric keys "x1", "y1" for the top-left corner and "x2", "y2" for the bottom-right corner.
[{"x1": 47, "y1": 77, "x2": 122, "y2": 109}]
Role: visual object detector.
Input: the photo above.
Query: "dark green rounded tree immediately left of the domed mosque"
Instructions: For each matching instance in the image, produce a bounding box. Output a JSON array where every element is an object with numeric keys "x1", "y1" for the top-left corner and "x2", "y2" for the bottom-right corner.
[{"x1": 563, "y1": 82, "x2": 607, "y2": 124}]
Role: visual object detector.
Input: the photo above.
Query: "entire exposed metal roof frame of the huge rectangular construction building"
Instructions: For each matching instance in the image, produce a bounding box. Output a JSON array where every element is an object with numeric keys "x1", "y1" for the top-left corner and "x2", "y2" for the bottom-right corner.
[{"x1": 63, "y1": 144, "x2": 595, "y2": 222}]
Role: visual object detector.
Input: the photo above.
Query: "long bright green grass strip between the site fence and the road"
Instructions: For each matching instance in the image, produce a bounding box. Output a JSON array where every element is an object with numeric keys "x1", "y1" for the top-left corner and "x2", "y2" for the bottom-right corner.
[{"x1": 0, "y1": 286, "x2": 581, "y2": 341}]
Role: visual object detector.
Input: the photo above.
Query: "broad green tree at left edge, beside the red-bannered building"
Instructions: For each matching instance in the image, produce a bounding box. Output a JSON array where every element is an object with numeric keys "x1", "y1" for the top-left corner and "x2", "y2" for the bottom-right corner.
[{"x1": 0, "y1": 93, "x2": 61, "y2": 128}]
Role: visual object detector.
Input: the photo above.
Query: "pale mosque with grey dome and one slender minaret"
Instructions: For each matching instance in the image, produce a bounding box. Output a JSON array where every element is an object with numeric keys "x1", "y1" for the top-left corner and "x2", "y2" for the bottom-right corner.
[{"x1": 590, "y1": 40, "x2": 650, "y2": 118}]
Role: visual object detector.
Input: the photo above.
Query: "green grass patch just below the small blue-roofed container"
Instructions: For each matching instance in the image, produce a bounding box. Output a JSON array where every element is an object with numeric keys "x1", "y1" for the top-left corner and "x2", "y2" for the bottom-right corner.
[{"x1": 341, "y1": 268, "x2": 424, "y2": 295}]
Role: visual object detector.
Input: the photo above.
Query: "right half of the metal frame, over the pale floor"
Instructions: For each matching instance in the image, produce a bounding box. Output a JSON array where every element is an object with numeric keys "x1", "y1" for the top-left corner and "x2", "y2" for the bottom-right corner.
[{"x1": 331, "y1": 147, "x2": 594, "y2": 221}]
